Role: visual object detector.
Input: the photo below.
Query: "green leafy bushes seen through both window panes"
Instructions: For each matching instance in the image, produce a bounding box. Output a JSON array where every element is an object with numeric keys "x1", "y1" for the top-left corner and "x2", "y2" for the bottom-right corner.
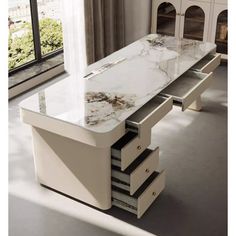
[{"x1": 8, "y1": 18, "x2": 63, "y2": 70}]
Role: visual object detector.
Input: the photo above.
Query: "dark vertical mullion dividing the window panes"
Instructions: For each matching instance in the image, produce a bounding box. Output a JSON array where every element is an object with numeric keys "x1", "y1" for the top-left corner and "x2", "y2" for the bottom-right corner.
[{"x1": 30, "y1": 0, "x2": 42, "y2": 61}]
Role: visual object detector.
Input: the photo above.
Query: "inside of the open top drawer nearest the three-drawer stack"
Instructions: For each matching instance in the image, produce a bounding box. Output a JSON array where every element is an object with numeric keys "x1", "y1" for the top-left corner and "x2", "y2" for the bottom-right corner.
[{"x1": 127, "y1": 96, "x2": 166, "y2": 123}]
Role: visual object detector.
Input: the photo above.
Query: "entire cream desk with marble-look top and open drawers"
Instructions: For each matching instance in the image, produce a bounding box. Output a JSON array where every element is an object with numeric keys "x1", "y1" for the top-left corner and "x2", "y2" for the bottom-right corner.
[{"x1": 20, "y1": 35, "x2": 220, "y2": 218}]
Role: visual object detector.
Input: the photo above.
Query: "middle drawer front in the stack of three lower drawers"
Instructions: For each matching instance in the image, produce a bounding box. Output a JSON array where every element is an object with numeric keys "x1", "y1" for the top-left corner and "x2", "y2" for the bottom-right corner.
[{"x1": 130, "y1": 148, "x2": 159, "y2": 195}]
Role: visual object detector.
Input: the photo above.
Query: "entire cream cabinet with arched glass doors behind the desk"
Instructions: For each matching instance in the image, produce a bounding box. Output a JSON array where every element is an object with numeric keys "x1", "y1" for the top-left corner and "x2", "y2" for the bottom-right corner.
[{"x1": 151, "y1": 0, "x2": 228, "y2": 55}]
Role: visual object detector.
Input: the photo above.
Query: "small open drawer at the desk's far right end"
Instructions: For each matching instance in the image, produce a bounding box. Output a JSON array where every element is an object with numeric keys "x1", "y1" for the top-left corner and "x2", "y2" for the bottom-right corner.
[{"x1": 191, "y1": 53, "x2": 221, "y2": 73}]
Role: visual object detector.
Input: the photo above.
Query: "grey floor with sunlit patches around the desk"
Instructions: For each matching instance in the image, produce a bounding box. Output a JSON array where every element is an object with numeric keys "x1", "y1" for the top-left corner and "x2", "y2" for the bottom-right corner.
[{"x1": 9, "y1": 66, "x2": 227, "y2": 236}]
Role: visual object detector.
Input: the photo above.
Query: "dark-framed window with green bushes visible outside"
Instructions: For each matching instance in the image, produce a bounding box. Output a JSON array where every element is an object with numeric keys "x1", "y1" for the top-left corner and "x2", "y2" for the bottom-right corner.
[{"x1": 8, "y1": 0, "x2": 63, "y2": 74}]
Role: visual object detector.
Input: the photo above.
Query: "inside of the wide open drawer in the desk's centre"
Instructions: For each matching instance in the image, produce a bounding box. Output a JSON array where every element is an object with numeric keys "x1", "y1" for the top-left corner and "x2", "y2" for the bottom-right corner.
[{"x1": 161, "y1": 71, "x2": 206, "y2": 102}]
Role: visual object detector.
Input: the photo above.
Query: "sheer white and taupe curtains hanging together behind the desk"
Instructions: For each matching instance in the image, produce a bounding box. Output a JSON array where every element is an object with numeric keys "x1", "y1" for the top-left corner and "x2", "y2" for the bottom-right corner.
[{"x1": 61, "y1": 0, "x2": 125, "y2": 75}]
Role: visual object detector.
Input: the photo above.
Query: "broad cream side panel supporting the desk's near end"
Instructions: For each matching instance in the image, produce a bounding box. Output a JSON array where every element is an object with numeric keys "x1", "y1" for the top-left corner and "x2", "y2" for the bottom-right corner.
[{"x1": 32, "y1": 127, "x2": 111, "y2": 210}]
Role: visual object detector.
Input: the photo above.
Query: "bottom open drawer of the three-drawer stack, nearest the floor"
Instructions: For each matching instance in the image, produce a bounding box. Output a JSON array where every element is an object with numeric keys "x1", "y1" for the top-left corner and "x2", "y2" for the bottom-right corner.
[{"x1": 112, "y1": 171, "x2": 165, "y2": 218}]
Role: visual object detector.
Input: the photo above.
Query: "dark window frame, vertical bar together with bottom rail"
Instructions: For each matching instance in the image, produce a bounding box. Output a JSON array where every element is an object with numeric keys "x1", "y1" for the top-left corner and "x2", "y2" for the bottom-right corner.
[{"x1": 8, "y1": 0, "x2": 63, "y2": 76}]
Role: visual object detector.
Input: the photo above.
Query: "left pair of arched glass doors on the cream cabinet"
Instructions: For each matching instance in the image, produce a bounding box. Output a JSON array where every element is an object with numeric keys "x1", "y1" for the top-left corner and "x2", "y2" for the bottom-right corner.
[{"x1": 151, "y1": 0, "x2": 211, "y2": 41}]
